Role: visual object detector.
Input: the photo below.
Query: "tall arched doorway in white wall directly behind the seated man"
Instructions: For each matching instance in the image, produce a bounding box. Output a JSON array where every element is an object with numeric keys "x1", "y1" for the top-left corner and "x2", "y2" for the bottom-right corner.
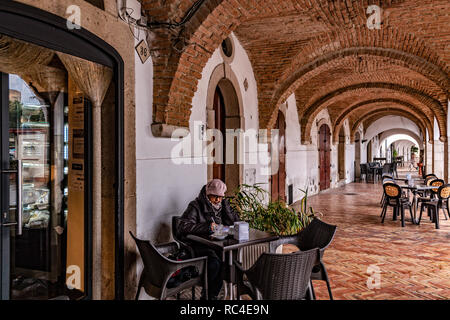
[{"x1": 208, "y1": 79, "x2": 241, "y2": 194}]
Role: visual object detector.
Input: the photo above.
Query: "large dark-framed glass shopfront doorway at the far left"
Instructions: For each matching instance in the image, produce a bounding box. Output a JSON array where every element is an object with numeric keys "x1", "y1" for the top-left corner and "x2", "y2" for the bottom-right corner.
[{"x1": 0, "y1": 1, "x2": 125, "y2": 300}]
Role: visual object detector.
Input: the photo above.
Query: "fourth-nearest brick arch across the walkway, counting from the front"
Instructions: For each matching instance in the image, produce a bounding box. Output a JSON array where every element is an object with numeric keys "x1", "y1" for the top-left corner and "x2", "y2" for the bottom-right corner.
[{"x1": 333, "y1": 98, "x2": 434, "y2": 141}]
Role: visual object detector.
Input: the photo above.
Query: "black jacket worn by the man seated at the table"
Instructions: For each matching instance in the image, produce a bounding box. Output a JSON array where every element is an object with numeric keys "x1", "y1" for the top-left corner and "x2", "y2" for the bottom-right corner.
[{"x1": 178, "y1": 186, "x2": 240, "y2": 237}]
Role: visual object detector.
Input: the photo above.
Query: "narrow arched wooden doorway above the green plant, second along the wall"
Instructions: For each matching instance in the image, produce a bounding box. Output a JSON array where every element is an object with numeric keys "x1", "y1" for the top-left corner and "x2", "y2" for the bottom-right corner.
[{"x1": 270, "y1": 111, "x2": 286, "y2": 201}]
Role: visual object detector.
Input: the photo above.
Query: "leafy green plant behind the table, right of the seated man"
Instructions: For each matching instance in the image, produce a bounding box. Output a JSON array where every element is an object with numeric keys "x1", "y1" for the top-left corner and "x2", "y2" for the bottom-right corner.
[{"x1": 230, "y1": 183, "x2": 315, "y2": 236}]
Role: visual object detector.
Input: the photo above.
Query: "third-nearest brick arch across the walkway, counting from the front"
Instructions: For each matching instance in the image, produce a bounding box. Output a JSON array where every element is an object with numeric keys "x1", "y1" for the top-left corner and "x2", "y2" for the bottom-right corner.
[{"x1": 300, "y1": 82, "x2": 447, "y2": 143}]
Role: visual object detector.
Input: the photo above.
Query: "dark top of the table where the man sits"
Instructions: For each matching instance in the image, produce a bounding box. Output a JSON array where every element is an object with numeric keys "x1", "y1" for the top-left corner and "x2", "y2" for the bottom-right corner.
[{"x1": 187, "y1": 228, "x2": 279, "y2": 252}]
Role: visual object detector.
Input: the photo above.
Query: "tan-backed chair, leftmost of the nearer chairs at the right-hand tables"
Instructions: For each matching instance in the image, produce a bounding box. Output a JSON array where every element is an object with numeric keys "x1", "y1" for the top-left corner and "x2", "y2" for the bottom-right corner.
[{"x1": 381, "y1": 182, "x2": 415, "y2": 227}]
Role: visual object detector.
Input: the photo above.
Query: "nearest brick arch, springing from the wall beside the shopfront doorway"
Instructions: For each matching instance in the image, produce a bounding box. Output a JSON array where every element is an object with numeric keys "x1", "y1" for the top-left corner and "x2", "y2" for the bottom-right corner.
[{"x1": 144, "y1": 0, "x2": 299, "y2": 127}]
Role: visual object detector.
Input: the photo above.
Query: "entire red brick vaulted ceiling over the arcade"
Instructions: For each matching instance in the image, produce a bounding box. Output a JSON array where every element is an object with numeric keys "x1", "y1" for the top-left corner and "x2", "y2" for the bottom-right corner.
[{"x1": 141, "y1": 0, "x2": 450, "y2": 143}]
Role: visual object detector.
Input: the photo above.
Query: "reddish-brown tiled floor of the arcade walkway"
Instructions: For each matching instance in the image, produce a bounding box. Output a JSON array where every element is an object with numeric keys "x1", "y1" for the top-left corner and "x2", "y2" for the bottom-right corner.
[{"x1": 183, "y1": 170, "x2": 450, "y2": 300}]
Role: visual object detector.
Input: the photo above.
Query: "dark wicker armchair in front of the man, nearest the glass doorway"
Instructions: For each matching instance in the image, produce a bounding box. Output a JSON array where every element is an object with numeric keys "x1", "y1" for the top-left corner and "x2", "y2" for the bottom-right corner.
[{"x1": 130, "y1": 231, "x2": 208, "y2": 300}]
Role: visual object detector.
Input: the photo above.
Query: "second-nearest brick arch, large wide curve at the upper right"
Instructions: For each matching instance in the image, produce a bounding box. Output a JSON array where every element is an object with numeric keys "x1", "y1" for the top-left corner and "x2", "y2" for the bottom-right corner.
[{"x1": 267, "y1": 27, "x2": 450, "y2": 126}]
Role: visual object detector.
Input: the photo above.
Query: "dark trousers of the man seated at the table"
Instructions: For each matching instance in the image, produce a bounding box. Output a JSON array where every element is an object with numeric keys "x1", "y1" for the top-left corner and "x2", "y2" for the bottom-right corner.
[{"x1": 194, "y1": 245, "x2": 224, "y2": 299}]
